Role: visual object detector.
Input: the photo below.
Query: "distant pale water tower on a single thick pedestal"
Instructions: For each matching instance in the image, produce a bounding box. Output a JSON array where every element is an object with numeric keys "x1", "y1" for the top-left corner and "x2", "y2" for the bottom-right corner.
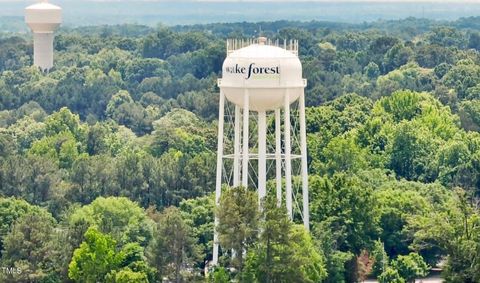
[{"x1": 25, "y1": 0, "x2": 62, "y2": 71}]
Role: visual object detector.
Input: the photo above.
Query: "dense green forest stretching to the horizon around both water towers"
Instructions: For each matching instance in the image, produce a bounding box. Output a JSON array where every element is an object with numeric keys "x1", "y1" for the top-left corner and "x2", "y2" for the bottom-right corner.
[{"x1": 0, "y1": 18, "x2": 480, "y2": 283}]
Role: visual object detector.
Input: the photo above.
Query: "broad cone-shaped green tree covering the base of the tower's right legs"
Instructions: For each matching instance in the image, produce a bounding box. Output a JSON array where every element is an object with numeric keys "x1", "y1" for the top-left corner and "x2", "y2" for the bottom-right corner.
[{"x1": 241, "y1": 197, "x2": 327, "y2": 282}]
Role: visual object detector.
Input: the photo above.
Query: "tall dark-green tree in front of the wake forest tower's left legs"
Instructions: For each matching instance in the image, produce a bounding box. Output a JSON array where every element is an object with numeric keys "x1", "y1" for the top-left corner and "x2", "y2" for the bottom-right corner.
[{"x1": 215, "y1": 187, "x2": 260, "y2": 271}]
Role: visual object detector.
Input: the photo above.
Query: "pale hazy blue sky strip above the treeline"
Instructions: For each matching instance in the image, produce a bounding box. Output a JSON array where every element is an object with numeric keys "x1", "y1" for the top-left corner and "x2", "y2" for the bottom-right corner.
[{"x1": 0, "y1": 0, "x2": 480, "y2": 28}]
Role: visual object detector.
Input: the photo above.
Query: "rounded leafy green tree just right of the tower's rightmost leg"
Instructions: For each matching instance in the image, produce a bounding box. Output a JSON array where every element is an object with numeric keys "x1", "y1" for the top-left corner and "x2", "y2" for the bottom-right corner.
[{"x1": 309, "y1": 173, "x2": 379, "y2": 254}]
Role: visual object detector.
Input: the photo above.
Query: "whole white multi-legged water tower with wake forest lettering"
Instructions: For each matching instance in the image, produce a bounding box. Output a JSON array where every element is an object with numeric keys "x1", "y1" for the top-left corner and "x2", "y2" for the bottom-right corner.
[{"x1": 213, "y1": 37, "x2": 309, "y2": 264}]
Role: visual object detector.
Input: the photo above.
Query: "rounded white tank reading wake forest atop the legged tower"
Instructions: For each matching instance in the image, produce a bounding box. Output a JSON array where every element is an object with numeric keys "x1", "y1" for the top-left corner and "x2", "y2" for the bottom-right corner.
[{"x1": 219, "y1": 37, "x2": 306, "y2": 111}]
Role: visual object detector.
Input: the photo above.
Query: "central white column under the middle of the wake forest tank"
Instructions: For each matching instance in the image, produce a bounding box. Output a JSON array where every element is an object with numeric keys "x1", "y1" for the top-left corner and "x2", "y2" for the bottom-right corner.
[{"x1": 258, "y1": 111, "x2": 267, "y2": 204}]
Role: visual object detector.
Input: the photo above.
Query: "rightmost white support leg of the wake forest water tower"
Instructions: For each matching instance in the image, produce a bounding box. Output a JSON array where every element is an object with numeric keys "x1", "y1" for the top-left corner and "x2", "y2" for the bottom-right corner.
[{"x1": 299, "y1": 92, "x2": 310, "y2": 231}]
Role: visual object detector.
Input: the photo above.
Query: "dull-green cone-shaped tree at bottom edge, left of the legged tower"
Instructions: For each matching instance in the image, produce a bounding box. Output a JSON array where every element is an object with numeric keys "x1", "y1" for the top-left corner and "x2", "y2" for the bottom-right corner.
[{"x1": 149, "y1": 207, "x2": 198, "y2": 283}]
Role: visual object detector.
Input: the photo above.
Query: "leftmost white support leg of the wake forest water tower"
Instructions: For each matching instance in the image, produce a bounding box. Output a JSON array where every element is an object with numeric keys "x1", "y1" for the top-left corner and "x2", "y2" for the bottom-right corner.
[{"x1": 213, "y1": 92, "x2": 225, "y2": 265}]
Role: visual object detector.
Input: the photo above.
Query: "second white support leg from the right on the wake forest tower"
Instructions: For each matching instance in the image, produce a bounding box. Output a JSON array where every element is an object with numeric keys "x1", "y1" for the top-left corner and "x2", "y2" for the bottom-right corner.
[{"x1": 285, "y1": 89, "x2": 293, "y2": 219}]
